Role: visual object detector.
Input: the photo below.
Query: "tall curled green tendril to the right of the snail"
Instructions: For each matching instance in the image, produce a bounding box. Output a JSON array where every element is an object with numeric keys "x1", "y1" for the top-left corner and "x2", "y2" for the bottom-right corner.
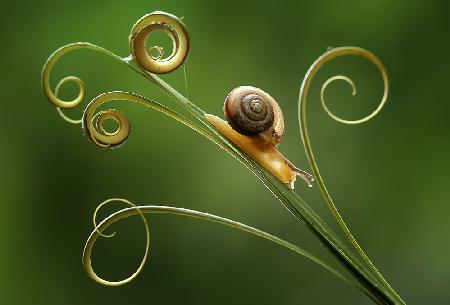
[{"x1": 298, "y1": 47, "x2": 403, "y2": 302}]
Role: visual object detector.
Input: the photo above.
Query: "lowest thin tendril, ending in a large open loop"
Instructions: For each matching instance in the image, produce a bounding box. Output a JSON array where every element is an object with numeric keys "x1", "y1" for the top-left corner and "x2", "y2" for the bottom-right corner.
[{"x1": 82, "y1": 198, "x2": 352, "y2": 289}]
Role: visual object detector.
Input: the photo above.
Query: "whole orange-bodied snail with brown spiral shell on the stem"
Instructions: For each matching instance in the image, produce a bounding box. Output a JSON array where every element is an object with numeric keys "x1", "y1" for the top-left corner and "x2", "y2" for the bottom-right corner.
[{"x1": 206, "y1": 86, "x2": 314, "y2": 188}]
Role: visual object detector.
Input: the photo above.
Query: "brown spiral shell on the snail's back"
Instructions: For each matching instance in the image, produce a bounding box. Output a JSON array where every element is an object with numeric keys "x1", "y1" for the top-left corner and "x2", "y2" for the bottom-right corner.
[{"x1": 224, "y1": 86, "x2": 284, "y2": 146}]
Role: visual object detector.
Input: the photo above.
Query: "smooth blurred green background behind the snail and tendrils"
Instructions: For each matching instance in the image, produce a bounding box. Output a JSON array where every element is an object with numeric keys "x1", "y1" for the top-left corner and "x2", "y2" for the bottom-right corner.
[{"x1": 0, "y1": 0, "x2": 450, "y2": 305}]
